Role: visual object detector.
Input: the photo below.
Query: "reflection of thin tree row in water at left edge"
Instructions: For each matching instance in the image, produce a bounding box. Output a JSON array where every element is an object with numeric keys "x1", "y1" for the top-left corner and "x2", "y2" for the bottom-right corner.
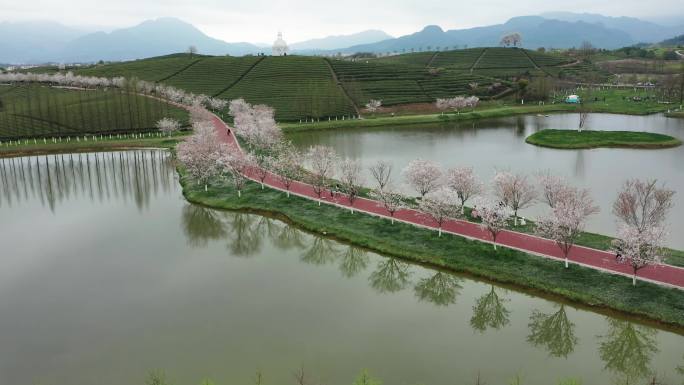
[{"x1": 0, "y1": 150, "x2": 175, "y2": 212}]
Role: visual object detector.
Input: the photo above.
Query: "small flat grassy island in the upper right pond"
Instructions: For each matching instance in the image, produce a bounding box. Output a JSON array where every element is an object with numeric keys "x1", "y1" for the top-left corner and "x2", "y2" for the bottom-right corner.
[{"x1": 525, "y1": 129, "x2": 682, "y2": 149}]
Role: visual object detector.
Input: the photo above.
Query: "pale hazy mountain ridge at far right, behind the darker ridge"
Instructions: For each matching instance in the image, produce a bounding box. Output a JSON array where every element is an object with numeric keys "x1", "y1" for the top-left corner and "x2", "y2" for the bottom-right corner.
[{"x1": 541, "y1": 12, "x2": 684, "y2": 43}]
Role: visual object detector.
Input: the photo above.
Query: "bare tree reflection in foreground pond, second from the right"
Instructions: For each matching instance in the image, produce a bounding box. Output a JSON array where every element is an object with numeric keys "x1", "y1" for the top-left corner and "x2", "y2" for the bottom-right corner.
[{"x1": 527, "y1": 305, "x2": 577, "y2": 358}]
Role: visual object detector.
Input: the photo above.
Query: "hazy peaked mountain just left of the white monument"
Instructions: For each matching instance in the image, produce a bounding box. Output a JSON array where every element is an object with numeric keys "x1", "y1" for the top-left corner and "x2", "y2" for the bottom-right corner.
[{"x1": 59, "y1": 18, "x2": 260, "y2": 62}]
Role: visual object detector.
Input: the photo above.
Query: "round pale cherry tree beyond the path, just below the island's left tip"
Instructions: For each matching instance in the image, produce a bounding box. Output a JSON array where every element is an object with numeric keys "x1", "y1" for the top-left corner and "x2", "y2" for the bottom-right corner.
[{"x1": 493, "y1": 171, "x2": 537, "y2": 226}]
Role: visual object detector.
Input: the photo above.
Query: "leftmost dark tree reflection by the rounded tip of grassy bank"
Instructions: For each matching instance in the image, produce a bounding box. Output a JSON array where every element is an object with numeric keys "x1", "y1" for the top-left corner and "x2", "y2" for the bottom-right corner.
[{"x1": 181, "y1": 204, "x2": 228, "y2": 247}]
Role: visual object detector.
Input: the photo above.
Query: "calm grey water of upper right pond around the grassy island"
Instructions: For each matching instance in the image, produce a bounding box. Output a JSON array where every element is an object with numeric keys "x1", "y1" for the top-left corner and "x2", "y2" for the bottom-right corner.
[{"x1": 291, "y1": 114, "x2": 684, "y2": 249}]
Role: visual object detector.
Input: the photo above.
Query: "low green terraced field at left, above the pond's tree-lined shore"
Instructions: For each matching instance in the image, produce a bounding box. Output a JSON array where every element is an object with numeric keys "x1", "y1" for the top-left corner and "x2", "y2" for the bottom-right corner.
[{"x1": 0, "y1": 84, "x2": 187, "y2": 141}]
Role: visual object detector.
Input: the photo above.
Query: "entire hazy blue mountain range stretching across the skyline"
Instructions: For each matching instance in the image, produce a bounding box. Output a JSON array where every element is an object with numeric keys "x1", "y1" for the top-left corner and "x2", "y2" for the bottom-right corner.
[{"x1": 0, "y1": 12, "x2": 684, "y2": 64}]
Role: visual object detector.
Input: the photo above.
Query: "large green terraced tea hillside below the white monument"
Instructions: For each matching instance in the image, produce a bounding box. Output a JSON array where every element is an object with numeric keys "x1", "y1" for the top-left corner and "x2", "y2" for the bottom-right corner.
[{"x1": 40, "y1": 48, "x2": 605, "y2": 121}]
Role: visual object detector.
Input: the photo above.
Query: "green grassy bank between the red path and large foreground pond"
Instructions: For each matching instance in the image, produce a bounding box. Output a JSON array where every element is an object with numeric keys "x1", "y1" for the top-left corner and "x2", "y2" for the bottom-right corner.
[{"x1": 181, "y1": 177, "x2": 684, "y2": 328}]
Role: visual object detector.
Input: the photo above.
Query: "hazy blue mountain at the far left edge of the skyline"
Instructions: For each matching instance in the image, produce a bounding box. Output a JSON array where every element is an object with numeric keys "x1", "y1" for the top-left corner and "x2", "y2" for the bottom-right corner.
[{"x1": 0, "y1": 21, "x2": 84, "y2": 63}]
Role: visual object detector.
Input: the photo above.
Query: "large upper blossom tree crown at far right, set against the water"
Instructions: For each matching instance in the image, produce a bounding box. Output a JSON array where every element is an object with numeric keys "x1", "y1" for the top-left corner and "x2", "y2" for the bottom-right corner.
[{"x1": 613, "y1": 179, "x2": 675, "y2": 232}]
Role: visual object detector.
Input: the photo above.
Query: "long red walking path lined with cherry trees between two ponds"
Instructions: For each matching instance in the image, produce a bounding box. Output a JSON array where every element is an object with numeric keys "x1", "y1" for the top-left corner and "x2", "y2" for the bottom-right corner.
[{"x1": 208, "y1": 116, "x2": 684, "y2": 289}]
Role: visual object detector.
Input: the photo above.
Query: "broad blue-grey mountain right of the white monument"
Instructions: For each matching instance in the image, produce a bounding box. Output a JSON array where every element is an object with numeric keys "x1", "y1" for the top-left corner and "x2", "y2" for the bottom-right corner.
[{"x1": 334, "y1": 16, "x2": 634, "y2": 53}]
